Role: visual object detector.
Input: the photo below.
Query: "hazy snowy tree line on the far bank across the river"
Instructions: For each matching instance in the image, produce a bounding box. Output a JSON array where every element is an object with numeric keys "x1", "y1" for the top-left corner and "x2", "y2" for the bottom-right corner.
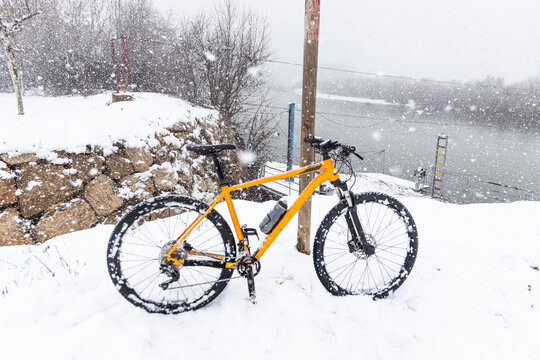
[{"x1": 320, "y1": 76, "x2": 540, "y2": 131}]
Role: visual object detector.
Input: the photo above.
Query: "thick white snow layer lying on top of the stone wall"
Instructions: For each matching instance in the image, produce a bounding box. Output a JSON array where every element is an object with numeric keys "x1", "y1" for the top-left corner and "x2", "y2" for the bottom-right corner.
[{"x1": 0, "y1": 93, "x2": 218, "y2": 158}]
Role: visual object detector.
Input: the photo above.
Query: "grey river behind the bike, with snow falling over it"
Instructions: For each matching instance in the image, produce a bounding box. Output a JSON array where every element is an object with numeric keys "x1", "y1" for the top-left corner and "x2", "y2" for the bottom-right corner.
[{"x1": 264, "y1": 90, "x2": 540, "y2": 203}]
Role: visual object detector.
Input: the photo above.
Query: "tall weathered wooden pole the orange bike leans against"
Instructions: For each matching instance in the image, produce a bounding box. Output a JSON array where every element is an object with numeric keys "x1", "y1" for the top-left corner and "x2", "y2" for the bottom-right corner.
[{"x1": 297, "y1": 0, "x2": 321, "y2": 254}]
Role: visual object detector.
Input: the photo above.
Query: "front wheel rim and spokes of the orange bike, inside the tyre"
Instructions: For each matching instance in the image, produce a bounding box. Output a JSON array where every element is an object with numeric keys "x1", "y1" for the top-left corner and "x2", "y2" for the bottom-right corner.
[{"x1": 323, "y1": 201, "x2": 411, "y2": 295}]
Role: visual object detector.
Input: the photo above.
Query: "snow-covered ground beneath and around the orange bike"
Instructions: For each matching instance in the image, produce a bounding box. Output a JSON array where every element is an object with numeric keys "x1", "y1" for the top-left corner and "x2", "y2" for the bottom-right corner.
[{"x1": 0, "y1": 175, "x2": 540, "y2": 360}]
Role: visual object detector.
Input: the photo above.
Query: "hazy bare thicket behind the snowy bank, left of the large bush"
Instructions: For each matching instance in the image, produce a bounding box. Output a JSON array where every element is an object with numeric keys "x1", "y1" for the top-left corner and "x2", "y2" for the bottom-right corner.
[{"x1": 0, "y1": 0, "x2": 215, "y2": 96}]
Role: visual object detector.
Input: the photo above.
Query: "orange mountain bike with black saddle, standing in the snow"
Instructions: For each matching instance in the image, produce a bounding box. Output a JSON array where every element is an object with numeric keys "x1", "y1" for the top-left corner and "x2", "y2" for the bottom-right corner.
[{"x1": 107, "y1": 138, "x2": 418, "y2": 313}]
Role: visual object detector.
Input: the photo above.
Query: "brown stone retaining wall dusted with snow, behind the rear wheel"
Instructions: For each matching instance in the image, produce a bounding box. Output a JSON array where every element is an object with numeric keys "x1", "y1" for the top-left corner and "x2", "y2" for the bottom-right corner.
[{"x1": 0, "y1": 118, "x2": 225, "y2": 246}]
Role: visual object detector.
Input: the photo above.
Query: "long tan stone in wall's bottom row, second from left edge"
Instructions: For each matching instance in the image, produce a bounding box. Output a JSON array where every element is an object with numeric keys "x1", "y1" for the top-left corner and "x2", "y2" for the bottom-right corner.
[{"x1": 35, "y1": 199, "x2": 98, "y2": 242}]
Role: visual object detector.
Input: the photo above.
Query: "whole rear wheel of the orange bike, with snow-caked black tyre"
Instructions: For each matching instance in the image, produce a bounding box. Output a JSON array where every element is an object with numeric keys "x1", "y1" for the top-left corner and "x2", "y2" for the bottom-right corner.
[{"x1": 107, "y1": 195, "x2": 236, "y2": 313}]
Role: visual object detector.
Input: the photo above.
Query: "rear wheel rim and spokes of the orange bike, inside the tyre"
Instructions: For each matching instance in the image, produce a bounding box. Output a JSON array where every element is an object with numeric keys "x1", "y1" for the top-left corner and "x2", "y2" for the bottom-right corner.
[{"x1": 115, "y1": 206, "x2": 231, "y2": 308}]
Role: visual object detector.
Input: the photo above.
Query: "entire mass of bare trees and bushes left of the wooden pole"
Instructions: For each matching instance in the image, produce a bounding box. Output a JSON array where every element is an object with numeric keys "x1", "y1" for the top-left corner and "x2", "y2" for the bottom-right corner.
[{"x1": 0, "y1": 0, "x2": 275, "y2": 180}]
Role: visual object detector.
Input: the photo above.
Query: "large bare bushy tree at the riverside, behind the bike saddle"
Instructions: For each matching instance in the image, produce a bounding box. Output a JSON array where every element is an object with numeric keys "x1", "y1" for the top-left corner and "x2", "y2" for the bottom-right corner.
[{"x1": 175, "y1": 1, "x2": 275, "y2": 176}]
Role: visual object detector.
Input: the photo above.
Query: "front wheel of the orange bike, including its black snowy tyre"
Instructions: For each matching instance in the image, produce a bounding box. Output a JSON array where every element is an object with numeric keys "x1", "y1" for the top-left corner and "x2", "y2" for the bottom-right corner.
[{"x1": 313, "y1": 193, "x2": 418, "y2": 298}]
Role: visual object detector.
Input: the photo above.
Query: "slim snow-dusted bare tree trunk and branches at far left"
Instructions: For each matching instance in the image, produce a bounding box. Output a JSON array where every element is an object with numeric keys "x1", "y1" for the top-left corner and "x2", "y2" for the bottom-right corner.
[{"x1": 0, "y1": 1, "x2": 39, "y2": 115}]
